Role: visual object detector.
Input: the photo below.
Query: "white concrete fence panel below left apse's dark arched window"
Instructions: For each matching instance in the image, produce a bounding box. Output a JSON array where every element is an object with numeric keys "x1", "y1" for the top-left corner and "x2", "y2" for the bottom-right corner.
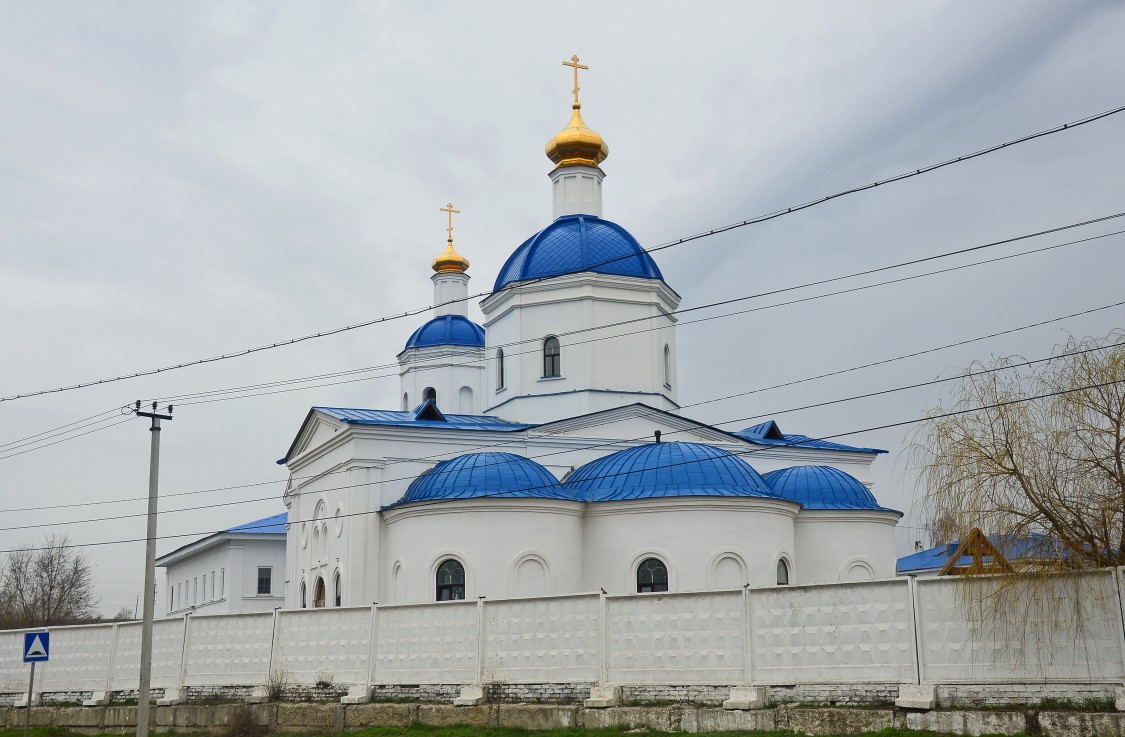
[{"x1": 375, "y1": 601, "x2": 477, "y2": 683}]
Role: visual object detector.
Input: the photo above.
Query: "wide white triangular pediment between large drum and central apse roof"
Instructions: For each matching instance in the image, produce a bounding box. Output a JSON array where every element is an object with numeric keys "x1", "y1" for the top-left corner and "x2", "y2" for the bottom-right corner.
[{"x1": 529, "y1": 403, "x2": 737, "y2": 443}]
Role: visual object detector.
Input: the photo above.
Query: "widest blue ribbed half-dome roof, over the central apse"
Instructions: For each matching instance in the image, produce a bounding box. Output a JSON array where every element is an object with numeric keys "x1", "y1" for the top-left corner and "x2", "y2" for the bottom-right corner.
[{"x1": 566, "y1": 442, "x2": 777, "y2": 502}]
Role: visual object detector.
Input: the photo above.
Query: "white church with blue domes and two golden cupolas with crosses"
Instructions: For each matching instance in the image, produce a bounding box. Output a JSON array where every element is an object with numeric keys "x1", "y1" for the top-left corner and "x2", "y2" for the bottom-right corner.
[{"x1": 279, "y1": 56, "x2": 901, "y2": 608}]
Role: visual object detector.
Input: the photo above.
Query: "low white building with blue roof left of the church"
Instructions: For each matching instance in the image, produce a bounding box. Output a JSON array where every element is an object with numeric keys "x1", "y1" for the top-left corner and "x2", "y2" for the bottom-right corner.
[{"x1": 156, "y1": 512, "x2": 288, "y2": 617}]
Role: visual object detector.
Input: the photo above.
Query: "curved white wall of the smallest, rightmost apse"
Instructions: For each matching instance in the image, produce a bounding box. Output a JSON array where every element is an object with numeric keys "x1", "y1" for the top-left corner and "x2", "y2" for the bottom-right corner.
[{"x1": 793, "y1": 510, "x2": 899, "y2": 584}]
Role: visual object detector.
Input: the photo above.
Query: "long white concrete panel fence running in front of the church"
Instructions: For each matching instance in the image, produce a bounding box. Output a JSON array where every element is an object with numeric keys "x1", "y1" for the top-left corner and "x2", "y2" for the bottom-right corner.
[{"x1": 0, "y1": 569, "x2": 1125, "y2": 699}]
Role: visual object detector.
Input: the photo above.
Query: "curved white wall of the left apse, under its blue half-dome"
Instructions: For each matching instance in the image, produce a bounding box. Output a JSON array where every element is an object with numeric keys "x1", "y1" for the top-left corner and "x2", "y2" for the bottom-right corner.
[{"x1": 380, "y1": 500, "x2": 583, "y2": 603}]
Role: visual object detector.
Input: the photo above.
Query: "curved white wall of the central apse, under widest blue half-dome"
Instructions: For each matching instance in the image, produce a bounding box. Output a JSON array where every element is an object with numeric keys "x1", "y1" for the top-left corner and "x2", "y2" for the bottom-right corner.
[{"x1": 582, "y1": 497, "x2": 798, "y2": 594}]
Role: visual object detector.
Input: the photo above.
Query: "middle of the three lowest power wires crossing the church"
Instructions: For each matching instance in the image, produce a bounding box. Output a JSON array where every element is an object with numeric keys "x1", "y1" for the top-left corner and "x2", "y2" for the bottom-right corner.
[{"x1": 0, "y1": 341, "x2": 1125, "y2": 531}]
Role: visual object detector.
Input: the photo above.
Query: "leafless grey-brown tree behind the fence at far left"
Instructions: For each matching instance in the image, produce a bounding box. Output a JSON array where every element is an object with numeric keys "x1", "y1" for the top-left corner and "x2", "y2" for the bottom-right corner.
[{"x1": 0, "y1": 536, "x2": 96, "y2": 628}]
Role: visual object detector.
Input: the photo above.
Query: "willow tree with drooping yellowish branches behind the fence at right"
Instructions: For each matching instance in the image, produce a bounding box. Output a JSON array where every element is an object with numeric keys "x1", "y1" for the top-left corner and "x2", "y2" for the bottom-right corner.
[{"x1": 911, "y1": 331, "x2": 1125, "y2": 572}]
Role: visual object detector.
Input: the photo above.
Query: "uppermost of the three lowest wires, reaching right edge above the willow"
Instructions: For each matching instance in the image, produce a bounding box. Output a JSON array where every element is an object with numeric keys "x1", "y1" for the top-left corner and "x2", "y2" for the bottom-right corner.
[{"x1": 0, "y1": 302, "x2": 1125, "y2": 512}]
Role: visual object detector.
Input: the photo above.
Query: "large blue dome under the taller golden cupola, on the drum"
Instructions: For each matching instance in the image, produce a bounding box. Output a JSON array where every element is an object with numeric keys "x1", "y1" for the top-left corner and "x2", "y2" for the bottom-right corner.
[{"x1": 493, "y1": 215, "x2": 664, "y2": 291}]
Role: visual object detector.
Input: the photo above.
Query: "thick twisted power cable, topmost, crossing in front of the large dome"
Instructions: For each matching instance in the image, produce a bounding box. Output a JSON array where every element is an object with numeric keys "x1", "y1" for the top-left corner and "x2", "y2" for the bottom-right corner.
[{"x1": 0, "y1": 106, "x2": 1125, "y2": 402}]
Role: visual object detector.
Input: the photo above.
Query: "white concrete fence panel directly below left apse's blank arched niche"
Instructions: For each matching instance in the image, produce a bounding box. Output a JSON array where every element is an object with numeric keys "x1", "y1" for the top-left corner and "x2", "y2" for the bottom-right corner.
[{"x1": 483, "y1": 594, "x2": 602, "y2": 683}]
